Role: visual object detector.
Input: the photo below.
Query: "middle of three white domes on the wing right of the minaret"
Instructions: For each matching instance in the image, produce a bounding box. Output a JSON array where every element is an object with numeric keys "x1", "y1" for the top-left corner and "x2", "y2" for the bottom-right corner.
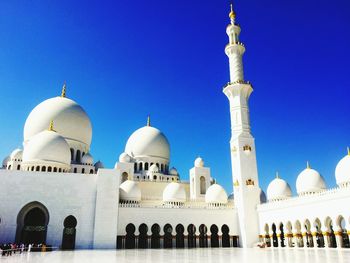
[{"x1": 296, "y1": 167, "x2": 326, "y2": 195}]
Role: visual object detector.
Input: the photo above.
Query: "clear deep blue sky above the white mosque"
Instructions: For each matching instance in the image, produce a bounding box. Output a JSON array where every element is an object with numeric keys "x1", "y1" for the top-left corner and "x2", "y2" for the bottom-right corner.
[{"x1": 0, "y1": 0, "x2": 350, "y2": 192}]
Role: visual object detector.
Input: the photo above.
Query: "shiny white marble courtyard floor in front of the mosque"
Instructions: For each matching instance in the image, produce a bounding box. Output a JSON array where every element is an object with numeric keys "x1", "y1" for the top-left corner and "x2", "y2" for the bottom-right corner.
[{"x1": 0, "y1": 248, "x2": 350, "y2": 263}]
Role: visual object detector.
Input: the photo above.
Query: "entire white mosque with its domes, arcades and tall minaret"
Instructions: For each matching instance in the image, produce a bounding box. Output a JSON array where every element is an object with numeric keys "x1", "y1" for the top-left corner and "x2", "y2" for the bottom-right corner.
[{"x1": 0, "y1": 4, "x2": 350, "y2": 249}]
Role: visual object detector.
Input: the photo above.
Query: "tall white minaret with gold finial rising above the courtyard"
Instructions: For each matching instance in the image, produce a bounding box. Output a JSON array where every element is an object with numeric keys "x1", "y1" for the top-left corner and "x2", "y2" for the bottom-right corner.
[{"x1": 223, "y1": 5, "x2": 260, "y2": 247}]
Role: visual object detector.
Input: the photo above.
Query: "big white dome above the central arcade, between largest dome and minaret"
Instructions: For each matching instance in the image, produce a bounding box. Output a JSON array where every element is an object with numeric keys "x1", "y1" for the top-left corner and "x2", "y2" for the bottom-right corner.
[{"x1": 125, "y1": 126, "x2": 170, "y2": 161}]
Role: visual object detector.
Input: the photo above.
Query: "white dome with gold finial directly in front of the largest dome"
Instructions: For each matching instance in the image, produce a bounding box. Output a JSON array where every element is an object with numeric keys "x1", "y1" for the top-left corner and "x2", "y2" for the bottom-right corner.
[{"x1": 23, "y1": 130, "x2": 71, "y2": 165}]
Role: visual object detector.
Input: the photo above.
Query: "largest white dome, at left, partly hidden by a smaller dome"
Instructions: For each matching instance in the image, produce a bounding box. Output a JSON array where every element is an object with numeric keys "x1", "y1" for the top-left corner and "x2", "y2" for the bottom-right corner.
[{"x1": 24, "y1": 97, "x2": 92, "y2": 151}]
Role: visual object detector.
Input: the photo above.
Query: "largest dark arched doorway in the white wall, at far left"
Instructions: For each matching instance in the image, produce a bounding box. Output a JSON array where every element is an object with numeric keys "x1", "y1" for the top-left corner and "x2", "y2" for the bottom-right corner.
[{"x1": 16, "y1": 202, "x2": 49, "y2": 244}]
